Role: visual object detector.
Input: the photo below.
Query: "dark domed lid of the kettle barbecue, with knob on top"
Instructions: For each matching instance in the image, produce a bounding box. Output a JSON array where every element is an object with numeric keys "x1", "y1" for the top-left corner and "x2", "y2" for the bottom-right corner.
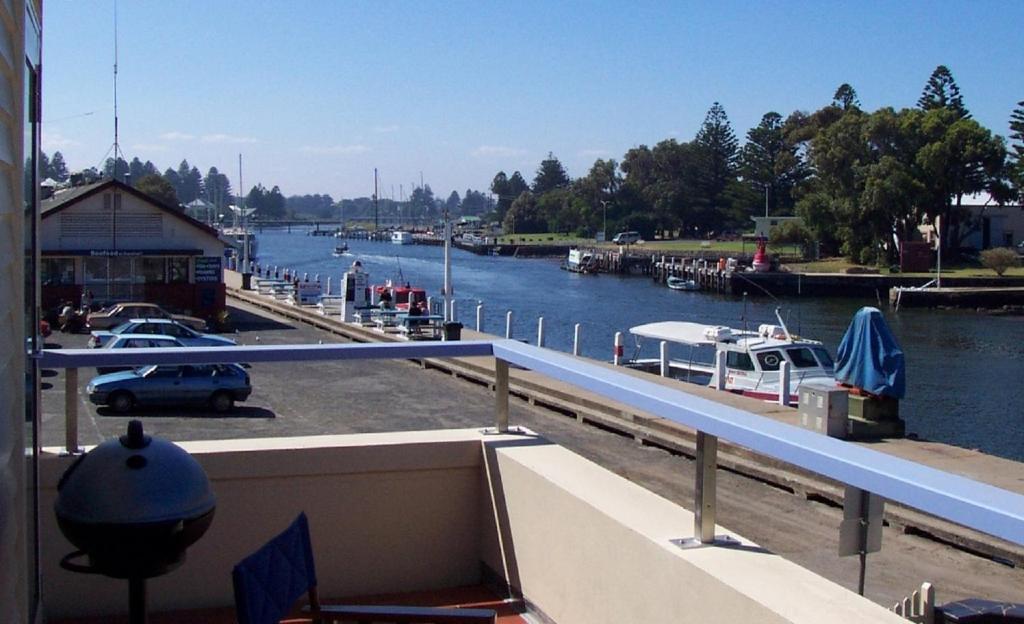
[{"x1": 54, "y1": 420, "x2": 216, "y2": 525}]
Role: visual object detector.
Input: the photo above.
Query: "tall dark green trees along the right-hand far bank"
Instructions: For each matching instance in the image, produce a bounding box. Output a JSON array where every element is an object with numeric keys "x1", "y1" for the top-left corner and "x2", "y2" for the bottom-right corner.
[{"x1": 490, "y1": 66, "x2": 1024, "y2": 263}]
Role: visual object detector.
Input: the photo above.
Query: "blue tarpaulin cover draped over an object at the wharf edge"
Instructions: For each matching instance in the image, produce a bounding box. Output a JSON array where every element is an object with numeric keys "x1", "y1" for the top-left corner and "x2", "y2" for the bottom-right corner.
[{"x1": 836, "y1": 307, "x2": 906, "y2": 399}]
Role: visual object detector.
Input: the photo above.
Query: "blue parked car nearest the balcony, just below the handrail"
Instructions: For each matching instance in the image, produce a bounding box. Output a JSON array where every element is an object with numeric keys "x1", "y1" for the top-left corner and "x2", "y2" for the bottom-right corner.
[{"x1": 87, "y1": 364, "x2": 252, "y2": 413}]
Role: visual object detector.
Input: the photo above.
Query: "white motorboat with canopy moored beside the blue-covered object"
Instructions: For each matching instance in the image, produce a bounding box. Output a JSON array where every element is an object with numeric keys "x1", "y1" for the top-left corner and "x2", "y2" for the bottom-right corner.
[{"x1": 627, "y1": 310, "x2": 836, "y2": 403}]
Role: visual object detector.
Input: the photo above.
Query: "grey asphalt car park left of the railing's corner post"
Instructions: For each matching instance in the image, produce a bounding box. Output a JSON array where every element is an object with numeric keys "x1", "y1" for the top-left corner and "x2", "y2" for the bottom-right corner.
[{"x1": 42, "y1": 304, "x2": 514, "y2": 446}]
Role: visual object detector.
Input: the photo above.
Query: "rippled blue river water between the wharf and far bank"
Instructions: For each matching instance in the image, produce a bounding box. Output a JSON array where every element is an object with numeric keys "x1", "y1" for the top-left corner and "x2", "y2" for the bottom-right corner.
[{"x1": 258, "y1": 228, "x2": 1024, "y2": 460}]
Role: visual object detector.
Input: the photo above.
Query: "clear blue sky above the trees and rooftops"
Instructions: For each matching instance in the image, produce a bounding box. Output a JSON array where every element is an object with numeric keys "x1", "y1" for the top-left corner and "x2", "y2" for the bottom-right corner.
[{"x1": 43, "y1": 0, "x2": 1024, "y2": 200}]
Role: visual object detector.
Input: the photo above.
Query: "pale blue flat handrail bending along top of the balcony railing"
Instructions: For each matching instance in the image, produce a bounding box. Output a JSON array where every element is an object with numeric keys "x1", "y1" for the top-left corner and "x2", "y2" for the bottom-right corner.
[{"x1": 40, "y1": 339, "x2": 1024, "y2": 545}]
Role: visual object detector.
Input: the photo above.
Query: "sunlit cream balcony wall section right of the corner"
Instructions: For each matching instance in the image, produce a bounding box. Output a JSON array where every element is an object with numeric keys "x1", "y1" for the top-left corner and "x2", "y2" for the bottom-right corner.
[{"x1": 481, "y1": 432, "x2": 905, "y2": 624}]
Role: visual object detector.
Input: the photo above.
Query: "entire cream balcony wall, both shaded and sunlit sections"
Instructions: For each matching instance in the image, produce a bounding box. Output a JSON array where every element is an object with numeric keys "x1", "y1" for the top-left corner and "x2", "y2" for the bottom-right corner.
[{"x1": 41, "y1": 429, "x2": 903, "y2": 624}]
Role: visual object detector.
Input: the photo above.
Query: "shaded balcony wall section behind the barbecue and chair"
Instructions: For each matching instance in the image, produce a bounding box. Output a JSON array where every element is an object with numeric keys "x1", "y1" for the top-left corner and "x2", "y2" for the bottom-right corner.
[{"x1": 40, "y1": 431, "x2": 481, "y2": 618}]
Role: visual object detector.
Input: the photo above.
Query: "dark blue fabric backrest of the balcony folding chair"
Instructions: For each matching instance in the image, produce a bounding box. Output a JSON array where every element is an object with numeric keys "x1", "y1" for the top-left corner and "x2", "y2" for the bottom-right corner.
[{"x1": 231, "y1": 513, "x2": 316, "y2": 624}]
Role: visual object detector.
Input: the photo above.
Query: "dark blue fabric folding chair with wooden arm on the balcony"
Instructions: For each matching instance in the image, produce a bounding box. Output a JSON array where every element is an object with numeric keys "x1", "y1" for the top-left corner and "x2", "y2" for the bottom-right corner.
[{"x1": 231, "y1": 513, "x2": 498, "y2": 624}]
